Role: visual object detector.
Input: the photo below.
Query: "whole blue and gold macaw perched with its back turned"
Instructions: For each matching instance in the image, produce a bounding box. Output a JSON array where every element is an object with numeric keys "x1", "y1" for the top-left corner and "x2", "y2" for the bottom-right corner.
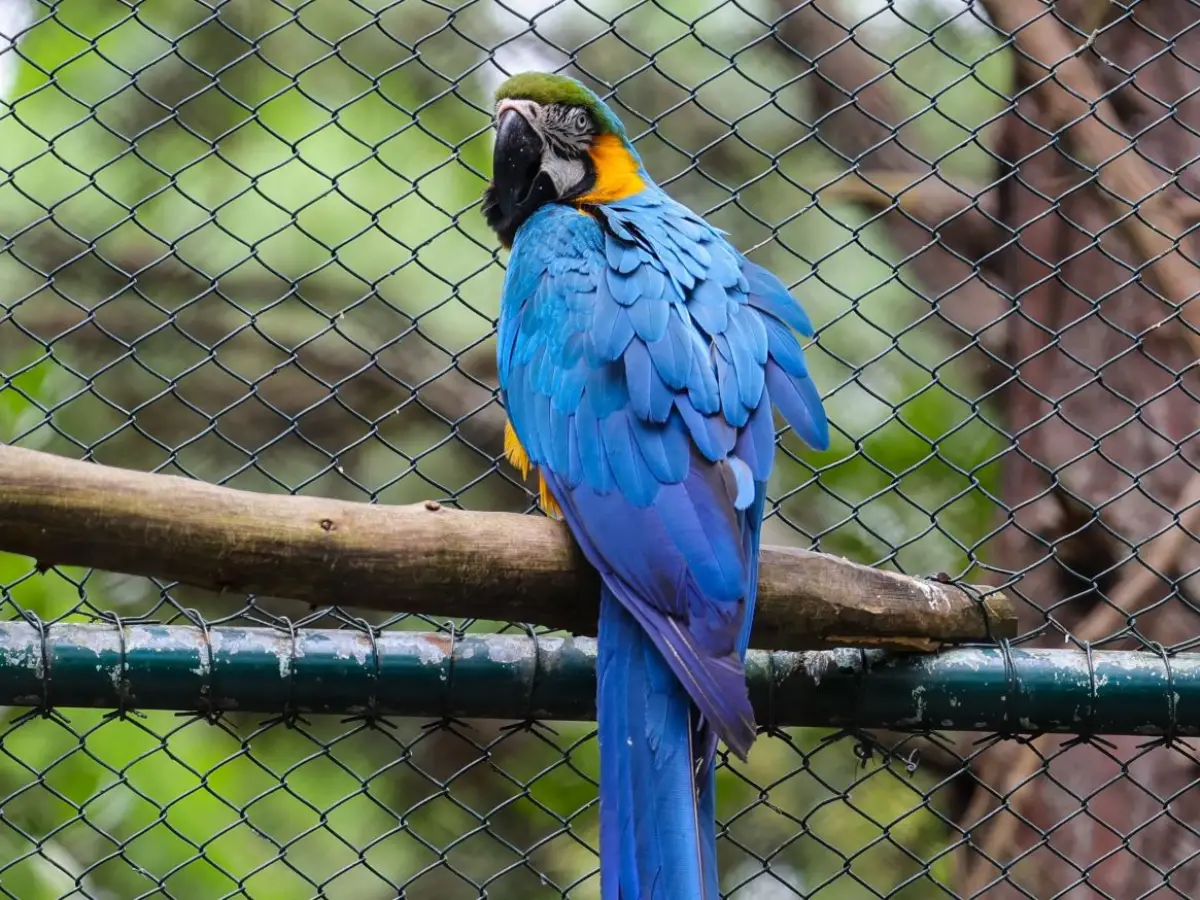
[{"x1": 484, "y1": 72, "x2": 829, "y2": 900}]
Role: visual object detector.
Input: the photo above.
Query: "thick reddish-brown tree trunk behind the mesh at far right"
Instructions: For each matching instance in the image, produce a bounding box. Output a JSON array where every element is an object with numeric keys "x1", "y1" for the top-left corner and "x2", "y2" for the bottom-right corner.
[{"x1": 958, "y1": 0, "x2": 1200, "y2": 898}]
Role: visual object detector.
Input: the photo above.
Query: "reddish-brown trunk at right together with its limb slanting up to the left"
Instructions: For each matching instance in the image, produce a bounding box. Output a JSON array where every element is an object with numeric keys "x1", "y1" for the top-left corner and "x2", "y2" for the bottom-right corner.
[{"x1": 779, "y1": 0, "x2": 1200, "y2": 900}]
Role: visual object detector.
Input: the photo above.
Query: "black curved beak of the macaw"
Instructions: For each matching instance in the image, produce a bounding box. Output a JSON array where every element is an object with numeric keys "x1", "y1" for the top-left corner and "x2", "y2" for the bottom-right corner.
[{"x1": 484, "y1": 109, "x2": 557, "y2": 246}]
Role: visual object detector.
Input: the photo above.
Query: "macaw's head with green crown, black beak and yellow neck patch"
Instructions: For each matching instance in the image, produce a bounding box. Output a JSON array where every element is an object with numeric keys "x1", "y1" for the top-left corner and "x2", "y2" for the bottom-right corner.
[{"x1": 484, "y1": 72, "x2": 648, "y2": 247}]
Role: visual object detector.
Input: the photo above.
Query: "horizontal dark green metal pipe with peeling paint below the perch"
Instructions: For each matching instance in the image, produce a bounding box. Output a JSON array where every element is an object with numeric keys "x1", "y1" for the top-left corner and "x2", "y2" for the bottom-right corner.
[{"x1": 0, "y1": 622, "x2": 1185, "y2": 736}]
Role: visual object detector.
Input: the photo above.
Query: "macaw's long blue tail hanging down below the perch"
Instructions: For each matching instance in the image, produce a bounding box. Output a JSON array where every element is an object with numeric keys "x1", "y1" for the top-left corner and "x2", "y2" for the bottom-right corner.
[{"x1": 596, "y1": 482, "x2": 766, "y2": 900}]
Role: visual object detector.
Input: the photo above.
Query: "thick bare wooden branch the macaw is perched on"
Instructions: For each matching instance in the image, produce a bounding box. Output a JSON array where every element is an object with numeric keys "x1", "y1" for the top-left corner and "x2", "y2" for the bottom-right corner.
[{"x1": 0, "y1": 446, "x2": 1016, "y2": 649}]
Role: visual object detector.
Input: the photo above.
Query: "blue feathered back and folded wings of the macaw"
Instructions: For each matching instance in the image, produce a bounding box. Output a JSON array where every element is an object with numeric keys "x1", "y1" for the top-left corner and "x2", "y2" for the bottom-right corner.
[{"x1": 498, "y1": 192, "x2": 828, "y2": 756}]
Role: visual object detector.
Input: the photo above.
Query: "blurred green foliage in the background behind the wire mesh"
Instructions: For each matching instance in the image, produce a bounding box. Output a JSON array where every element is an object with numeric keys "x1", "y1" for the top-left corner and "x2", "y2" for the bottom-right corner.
[{"x1": 0, "y1": 0, "x2": 1010, "y2": 900}]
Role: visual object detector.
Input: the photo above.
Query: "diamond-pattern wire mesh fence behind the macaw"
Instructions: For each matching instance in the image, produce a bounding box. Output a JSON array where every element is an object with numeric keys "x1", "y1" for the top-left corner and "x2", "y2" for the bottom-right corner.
[{"x1": 0, "y1": 0, "x2": 1200, "y2": 900}]
